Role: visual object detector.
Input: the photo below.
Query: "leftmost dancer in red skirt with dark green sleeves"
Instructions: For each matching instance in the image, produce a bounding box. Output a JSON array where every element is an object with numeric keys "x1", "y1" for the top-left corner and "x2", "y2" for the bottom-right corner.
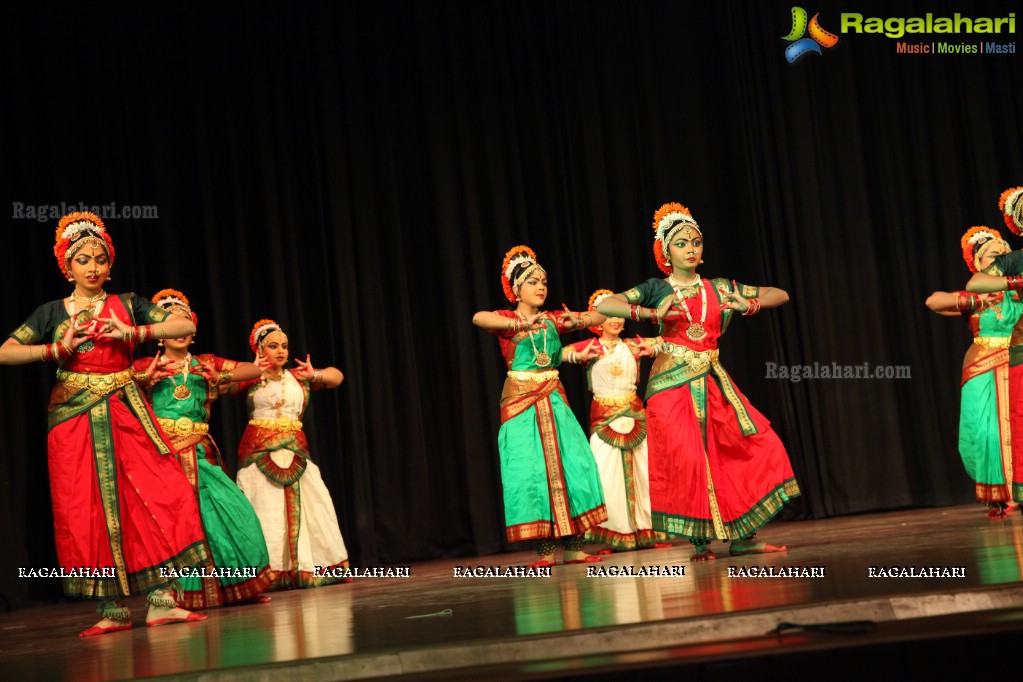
[{"x1": 0, "y1": 213, "x2": 206, "y2": 637}]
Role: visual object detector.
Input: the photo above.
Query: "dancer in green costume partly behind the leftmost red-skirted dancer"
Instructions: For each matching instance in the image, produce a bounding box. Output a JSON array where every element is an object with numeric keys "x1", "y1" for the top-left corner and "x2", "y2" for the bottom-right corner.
[{"x1": 135, "y1": 289, "x2": 273, "y2": 608}]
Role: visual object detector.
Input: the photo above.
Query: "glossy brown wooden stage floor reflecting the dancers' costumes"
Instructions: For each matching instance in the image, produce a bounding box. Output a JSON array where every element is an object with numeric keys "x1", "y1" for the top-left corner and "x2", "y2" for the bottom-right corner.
[{"x1": 0, "y1": 505, "x2": 1023, "y2": 680}]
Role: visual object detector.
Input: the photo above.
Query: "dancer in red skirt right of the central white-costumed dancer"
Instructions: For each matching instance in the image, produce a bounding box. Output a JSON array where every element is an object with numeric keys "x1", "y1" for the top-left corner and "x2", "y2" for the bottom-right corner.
[{"x1": 596, "y1": 203, "x2": 799, "y2": 561}]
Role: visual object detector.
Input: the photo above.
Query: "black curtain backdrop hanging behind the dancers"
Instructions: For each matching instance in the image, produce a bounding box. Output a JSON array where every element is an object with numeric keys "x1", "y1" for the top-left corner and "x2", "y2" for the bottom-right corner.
[{"x1": 0, "y1": 0, "x2": 1023, "y2": 606}]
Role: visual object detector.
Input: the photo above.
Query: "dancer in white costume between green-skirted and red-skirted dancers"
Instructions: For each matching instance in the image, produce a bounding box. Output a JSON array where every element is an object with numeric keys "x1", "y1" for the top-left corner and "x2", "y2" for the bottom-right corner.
[{"x1": 572, "y1": 289, "x2": 671, "y2": 554}]
